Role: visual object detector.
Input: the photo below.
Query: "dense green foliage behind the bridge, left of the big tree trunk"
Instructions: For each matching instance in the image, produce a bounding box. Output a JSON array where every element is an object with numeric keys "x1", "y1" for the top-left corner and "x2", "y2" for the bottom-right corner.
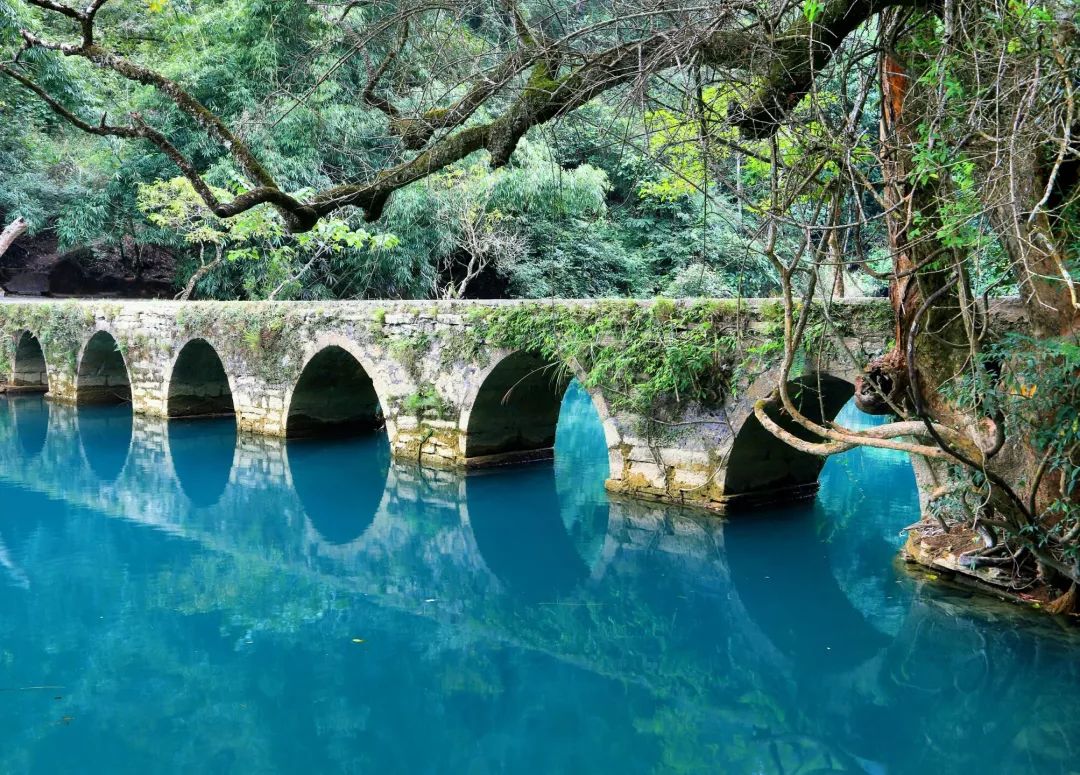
[{"x1": 0, "y1": 0, "x2": 816, "y2": 298}]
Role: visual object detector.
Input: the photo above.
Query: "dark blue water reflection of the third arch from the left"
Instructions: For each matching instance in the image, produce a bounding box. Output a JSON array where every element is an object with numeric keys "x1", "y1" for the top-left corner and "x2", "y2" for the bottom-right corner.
[{"x1": 168, "y1": 419, "x2": 237, "y2": 507}]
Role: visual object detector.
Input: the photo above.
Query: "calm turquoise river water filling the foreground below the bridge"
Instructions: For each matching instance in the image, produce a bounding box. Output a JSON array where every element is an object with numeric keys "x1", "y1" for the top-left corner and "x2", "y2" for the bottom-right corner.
[{"x1": 0, "y1": 389, "x2": 1080, "y2": 774}]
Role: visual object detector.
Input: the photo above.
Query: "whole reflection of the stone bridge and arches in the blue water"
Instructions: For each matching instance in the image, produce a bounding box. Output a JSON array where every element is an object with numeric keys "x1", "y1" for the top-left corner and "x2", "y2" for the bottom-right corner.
[{"x1": 0, "y1": 398, "x2": 1071, "y2": 771}]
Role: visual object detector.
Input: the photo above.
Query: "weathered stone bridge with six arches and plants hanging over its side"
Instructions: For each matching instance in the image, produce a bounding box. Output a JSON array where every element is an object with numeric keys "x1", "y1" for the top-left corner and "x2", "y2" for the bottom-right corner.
[{"x1": 0, "y1": 299, "x2": 1012, "y2": 509}]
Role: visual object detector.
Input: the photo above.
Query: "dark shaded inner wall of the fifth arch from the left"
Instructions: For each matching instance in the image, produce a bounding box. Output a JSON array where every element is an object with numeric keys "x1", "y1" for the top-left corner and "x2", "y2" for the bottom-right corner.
[{"x1": 465, "y1": 352, "x2": 570, "y2": 466}]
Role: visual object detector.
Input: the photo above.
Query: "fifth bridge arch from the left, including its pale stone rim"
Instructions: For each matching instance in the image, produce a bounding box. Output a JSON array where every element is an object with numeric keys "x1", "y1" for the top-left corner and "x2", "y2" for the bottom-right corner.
[{"x1": 459, "y1": 351, "x2": 622, "y2": 476}]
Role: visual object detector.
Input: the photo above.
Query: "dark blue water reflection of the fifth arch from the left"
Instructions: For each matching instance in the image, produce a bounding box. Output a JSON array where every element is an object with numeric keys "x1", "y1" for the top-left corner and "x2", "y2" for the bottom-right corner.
[{"x1": 465, "y1": 466, "x2": 590, "y2": 602}]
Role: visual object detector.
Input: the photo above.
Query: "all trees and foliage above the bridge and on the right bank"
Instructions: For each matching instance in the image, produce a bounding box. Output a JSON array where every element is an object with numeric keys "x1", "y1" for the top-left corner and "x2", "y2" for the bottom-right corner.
[{"x1": 0, "y1": 0, "x2": 1080, "y2": 607}]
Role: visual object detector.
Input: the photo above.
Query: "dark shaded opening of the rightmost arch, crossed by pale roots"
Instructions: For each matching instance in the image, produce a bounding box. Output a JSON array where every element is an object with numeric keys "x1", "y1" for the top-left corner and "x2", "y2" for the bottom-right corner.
[{"x1": 724, "y1": 373, "x2": 854, "y2": 506}]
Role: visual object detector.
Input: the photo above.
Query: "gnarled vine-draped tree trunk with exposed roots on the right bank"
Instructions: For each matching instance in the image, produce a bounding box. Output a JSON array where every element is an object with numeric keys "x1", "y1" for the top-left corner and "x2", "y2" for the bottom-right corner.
[{"x1": 856, "y1": 13, "x2": 1080, "y2": 587}]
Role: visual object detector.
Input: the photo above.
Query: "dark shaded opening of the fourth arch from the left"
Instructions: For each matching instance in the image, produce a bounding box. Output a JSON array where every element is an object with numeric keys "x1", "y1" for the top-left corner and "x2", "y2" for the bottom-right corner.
[{"x1": 285, "y1": 345, "x2": 382, "y2": 438}]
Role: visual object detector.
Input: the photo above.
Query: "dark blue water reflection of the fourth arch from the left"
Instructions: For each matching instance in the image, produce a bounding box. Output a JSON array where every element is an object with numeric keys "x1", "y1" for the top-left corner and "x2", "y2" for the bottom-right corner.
[{"x1": 288, "y1": 434, "x2": 390, "y2": 546}]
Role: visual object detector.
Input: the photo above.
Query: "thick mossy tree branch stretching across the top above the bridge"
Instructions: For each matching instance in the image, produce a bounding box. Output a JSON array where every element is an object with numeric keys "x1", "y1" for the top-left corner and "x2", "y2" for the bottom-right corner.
[{"x1": 6, "y1": 0, "x2": 921, "y2": 231}]
